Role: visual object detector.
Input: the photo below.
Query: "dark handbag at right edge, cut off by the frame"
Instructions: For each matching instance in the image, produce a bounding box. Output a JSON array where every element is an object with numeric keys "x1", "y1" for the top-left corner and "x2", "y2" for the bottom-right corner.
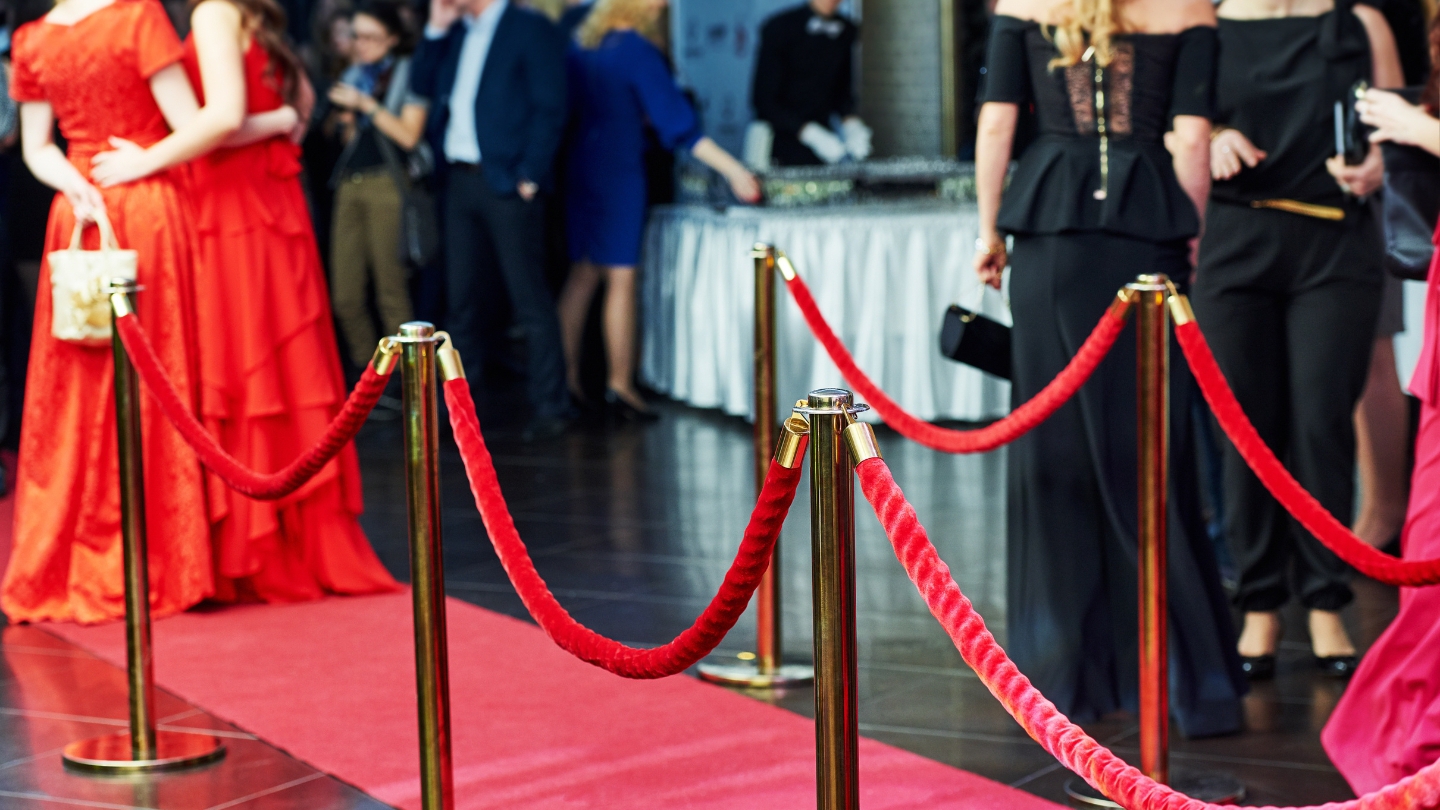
[{"x1": 1380, "y1": 88, "x2": 1440, "y2": 281}]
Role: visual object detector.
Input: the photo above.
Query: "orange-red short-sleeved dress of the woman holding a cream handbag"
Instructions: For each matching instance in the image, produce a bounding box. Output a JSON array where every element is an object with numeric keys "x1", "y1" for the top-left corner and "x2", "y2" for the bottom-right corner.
[{"x1": 0, "y1": 0, "x2": 213, "y2": 623}]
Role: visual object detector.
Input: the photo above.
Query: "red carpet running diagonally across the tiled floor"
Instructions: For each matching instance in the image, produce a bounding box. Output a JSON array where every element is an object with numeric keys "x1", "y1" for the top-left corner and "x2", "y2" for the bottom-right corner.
[{"x1": 45, "y1": 594, "x2": 1056, "y2": 810}]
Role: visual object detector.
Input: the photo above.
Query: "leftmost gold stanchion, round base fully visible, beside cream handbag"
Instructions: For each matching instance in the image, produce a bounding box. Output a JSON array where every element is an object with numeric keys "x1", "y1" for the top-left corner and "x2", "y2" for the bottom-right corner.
[{"x1": 62, "y1": 278, "x2": 225, "y2": 774}]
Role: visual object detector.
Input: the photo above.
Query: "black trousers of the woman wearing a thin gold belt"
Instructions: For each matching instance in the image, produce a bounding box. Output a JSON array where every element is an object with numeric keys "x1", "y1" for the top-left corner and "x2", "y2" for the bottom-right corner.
[{"x1": 1192, "y1": 202, "x2": 1384, "y2": 611}]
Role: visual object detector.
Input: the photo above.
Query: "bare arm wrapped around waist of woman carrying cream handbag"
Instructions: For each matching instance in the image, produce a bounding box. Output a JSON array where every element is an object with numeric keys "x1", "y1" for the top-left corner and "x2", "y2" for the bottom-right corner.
[{"x1": 91, "y1": 0, "x2": 245, "y2": 186}]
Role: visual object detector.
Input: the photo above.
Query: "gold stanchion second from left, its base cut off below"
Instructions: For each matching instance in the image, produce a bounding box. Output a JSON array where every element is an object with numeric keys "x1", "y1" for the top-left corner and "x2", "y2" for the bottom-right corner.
[{"x1": 390, "y1": 321, "x2": 458, "y2": 810}]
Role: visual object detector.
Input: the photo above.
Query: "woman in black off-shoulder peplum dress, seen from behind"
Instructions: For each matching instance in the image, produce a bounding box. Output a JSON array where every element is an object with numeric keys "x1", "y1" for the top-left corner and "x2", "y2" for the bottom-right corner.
[{"x1": 975, "y1": 0, "x2": 1246, "y2": 736}]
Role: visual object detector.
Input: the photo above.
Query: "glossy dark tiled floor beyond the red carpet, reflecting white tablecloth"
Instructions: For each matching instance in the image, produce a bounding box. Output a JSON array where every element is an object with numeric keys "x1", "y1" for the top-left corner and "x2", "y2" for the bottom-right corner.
[{"x1": 348, "y1": 380, "x2": 1395, "y2": 804}]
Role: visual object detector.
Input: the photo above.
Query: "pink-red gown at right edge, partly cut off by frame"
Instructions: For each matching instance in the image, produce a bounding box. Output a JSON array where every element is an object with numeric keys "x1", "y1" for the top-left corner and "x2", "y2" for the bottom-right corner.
[{"x1": 1320, "y1": 214, "x2": 1440, "y2": 794}]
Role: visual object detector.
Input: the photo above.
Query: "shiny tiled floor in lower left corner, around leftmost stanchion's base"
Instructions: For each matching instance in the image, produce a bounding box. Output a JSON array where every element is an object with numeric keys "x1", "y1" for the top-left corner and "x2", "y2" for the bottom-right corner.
[{"x1": 0, "y1": 616, "x2": 389, "y2": 810}]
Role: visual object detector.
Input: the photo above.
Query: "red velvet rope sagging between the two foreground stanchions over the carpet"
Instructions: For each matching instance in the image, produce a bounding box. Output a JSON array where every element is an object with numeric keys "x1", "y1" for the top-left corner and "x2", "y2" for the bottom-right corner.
[{"x1": 445, "y1": 379, "x2": 801, "y2": 679}]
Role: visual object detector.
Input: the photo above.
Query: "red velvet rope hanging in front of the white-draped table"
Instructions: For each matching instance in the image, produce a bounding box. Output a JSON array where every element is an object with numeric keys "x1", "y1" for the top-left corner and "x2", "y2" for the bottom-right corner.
[{"x1": 786, "y1": 277, "x2": 1129, "y2": 453}]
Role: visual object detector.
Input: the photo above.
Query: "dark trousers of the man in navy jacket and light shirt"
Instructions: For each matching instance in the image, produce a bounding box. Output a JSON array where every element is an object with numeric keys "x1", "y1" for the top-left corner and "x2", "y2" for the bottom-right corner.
[{"x1": 444, "y1": 166, "x2": 570, "y2": 417}]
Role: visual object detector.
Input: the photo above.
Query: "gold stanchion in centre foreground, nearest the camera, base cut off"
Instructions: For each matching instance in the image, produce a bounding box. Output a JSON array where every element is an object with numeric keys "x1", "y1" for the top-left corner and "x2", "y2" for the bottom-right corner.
[{"x1": 804, "y1": 389, "x2": 861, "y2": 810}]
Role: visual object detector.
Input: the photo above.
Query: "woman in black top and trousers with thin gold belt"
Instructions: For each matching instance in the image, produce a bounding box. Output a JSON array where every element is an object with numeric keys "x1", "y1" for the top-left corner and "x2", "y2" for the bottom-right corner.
[{"x1": 1194, "y1": 0, "x2": 1401, "y2": 679}]
